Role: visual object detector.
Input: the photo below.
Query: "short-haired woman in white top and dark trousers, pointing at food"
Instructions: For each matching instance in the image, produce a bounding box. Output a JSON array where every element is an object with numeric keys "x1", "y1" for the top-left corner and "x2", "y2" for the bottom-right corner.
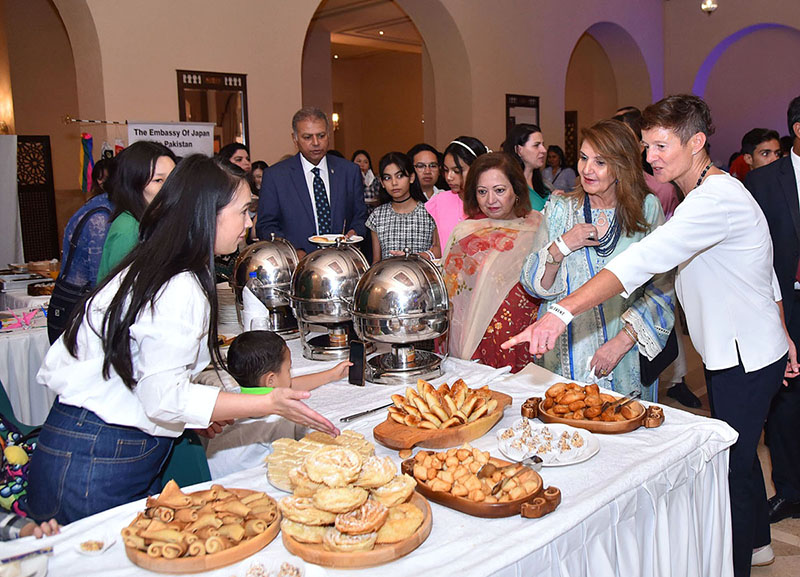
[{"x1": 503, "y1": 95, "x2": 800, "y2": 577}]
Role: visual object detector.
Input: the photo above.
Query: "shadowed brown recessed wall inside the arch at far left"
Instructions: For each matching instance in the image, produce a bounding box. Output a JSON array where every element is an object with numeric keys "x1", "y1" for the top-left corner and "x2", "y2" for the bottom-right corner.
[{"x1": 4, "y1": 0, "x2": 79, "y2": 196}]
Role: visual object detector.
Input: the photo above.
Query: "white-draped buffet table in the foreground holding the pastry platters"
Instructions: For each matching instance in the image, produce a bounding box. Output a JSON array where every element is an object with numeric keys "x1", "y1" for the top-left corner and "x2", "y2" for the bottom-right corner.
[{"x1": 0, "y1": 342, "x2": 736, "y2": 577}]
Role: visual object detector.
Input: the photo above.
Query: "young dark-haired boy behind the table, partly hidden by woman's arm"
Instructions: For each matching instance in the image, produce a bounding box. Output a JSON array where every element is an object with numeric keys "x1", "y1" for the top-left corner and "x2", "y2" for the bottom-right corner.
[{"x1": 204, "y1": 331, "x2": 350, "y2": 479}]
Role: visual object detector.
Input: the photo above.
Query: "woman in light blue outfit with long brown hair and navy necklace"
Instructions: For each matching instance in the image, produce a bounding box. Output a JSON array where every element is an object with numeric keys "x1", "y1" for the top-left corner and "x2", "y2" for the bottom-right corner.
[{"x1": 522, "y1": 120, "x2": 675, "y2": 401}]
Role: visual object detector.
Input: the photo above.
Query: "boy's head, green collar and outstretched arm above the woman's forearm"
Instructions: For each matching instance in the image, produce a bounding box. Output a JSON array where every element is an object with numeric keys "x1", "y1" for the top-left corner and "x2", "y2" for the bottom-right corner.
[{"x1": 227, "y1": 331, "x2": 352, "y2": 395}]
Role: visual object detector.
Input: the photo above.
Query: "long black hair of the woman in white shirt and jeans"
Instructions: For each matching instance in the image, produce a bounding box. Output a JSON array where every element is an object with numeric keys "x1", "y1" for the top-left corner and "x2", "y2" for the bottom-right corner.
[{"x1": 64, "y1": 154, "x2": 246, "y2": 389}]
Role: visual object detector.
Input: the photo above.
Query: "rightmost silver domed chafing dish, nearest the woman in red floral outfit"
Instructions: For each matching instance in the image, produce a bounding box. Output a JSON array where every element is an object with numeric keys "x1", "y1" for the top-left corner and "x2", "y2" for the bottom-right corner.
[{"x1": 351, "y1": 251, "x2": 450, "y2": 385}]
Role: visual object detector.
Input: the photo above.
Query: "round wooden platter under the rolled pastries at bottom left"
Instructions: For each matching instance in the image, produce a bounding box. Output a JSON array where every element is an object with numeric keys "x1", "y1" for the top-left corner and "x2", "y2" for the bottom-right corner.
[{"x1": 125, "y1": 488, "x2": 281, "y2": 573}]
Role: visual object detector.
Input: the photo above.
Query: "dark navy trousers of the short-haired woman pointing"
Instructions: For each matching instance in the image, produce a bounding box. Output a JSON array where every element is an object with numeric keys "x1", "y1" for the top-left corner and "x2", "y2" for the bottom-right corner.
[{"x1": 705, "y1": 355, "x2": 786, "y2": 577}]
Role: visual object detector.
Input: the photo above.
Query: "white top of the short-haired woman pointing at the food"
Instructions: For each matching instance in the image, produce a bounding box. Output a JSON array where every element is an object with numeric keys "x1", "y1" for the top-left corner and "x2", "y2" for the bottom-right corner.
[{"x1": 606, "y1": 174, "x2": 789, "y2": 372}]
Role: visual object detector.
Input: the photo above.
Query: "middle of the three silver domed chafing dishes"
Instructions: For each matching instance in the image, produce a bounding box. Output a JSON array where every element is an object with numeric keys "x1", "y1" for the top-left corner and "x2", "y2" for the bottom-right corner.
[{"x1": 291, "y1": 241, "x2": 369, "y2": 360}]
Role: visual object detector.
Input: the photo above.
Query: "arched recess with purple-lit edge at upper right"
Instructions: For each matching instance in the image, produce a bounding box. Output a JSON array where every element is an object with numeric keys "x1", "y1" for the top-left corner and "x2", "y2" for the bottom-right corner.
[{"x1": 692, "y1": 23, "x2": 800, "y2": 167}]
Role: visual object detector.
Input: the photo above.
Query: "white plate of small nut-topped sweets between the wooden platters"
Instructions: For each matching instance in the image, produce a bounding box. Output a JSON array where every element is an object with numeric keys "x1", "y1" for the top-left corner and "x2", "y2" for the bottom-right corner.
[{"x1": 497, "y1": 418, "x2": 600, "y2": 467}]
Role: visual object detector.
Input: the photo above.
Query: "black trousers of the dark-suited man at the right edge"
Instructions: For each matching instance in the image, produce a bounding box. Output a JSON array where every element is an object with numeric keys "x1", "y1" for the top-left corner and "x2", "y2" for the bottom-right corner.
[{"x1": 764, "y1": 291, "x2": 800, "y2": 501}]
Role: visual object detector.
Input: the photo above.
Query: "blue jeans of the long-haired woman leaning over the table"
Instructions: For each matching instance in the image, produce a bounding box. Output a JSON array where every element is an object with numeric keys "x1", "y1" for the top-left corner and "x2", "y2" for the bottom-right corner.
[{"x1": 26, "y1": 400, "x2": 174, "y2": 524}]
